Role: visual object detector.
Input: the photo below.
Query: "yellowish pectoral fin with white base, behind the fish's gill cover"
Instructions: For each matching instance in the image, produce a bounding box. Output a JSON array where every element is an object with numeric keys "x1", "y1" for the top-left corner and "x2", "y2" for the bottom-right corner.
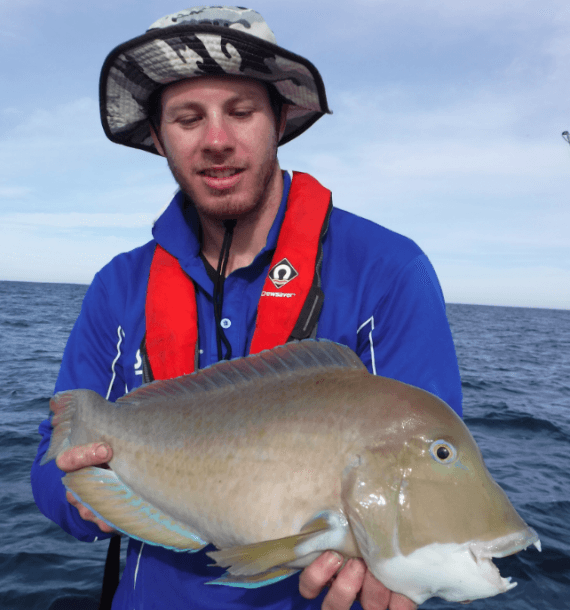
[{"x1": 208, "y1": 511, "x2": 348, "y2": 586}]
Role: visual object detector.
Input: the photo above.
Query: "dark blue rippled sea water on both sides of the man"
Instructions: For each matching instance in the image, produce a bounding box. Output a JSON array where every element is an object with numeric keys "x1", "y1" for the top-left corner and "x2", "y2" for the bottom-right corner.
[{"x1": 0, "y1": 282, "x2": 570, "y2": 610}]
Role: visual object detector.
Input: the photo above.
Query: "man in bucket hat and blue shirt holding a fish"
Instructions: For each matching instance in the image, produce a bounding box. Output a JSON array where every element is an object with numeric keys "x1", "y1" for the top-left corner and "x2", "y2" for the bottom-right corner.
[{"x1": 32, "y1": 7, "x2": 461, "y2": 610}]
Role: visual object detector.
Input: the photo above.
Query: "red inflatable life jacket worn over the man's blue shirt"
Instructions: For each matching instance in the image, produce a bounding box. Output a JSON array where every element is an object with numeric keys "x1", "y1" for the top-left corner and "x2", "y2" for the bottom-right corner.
[{"x1": 141, "y1": 172, "x2": 332, "y2": 380}]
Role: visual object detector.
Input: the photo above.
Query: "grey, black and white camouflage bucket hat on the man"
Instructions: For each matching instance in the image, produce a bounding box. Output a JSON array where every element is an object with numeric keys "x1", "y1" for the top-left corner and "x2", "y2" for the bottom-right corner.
[{"x1": 99, "y1": 6, "x2": 330, "y2": 154}]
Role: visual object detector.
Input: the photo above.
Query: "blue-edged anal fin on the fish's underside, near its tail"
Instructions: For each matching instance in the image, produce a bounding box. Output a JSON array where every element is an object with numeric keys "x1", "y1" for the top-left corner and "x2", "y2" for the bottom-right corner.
[{"x1": 63, "y1": 468, "x2": 207, "y2": 551}]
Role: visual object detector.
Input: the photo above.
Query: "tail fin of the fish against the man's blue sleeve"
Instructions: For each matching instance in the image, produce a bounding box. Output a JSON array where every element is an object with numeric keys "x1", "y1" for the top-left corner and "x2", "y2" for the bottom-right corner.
[{"x1": 40, "y1": 390, "x2": 107, "y2": 466}]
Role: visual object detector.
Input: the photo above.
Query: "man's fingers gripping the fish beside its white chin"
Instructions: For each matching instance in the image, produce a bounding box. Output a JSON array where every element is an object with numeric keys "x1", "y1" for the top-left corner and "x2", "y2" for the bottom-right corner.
[{"x1": 299, "y1": 551, "x2": 417, "y2": 610}]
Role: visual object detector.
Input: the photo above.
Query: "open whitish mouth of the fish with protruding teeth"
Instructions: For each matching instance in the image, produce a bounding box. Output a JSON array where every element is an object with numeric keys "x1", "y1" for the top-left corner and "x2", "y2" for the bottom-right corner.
[{"x1": 469, "y1": 527, "x2": 542, "y2": 592}]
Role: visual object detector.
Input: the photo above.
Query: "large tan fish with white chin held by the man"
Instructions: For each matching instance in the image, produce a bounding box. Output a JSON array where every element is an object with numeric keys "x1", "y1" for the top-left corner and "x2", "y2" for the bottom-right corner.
[{"x1": 42, "y1": 340, "x2": 540, "y2": 604}]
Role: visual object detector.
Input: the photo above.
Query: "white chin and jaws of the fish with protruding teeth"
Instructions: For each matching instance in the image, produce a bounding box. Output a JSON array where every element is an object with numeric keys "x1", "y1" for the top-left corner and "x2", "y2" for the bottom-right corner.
[{"x1": 373, "y1": 528, "x2": 541, "y2": 604}]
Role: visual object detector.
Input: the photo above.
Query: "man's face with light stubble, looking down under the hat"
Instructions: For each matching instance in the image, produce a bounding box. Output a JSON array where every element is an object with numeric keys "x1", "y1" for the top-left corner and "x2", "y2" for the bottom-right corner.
[{"x1": 153, "y1": 76, "x2": 285, "y2": 219}]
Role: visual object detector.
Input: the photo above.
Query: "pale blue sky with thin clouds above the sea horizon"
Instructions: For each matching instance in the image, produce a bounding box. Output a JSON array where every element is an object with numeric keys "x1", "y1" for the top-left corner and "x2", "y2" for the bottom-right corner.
[{"x1": 0, "y1": 0, "x2": 570, "y2": 309}]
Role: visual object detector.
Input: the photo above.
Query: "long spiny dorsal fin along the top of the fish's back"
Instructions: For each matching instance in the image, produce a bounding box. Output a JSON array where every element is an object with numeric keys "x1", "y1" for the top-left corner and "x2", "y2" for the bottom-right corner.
[{"x1": 117, "y1": 339, "x2": 366, "y2": 406}]
